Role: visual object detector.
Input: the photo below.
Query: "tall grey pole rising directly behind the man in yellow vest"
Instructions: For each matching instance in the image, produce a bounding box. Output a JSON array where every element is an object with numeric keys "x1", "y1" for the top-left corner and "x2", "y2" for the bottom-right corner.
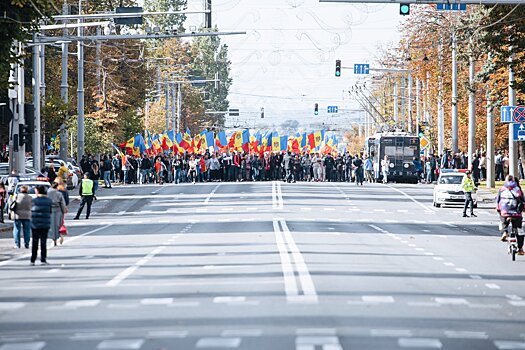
[{"x1": 77, "y1": 0, "x2": 85, "y2": 163}]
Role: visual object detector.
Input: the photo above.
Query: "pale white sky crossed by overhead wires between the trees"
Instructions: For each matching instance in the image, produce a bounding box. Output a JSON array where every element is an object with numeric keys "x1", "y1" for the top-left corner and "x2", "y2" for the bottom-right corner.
[{"x1": 182, "y1": 0, "x2": 403, "y2": 127}]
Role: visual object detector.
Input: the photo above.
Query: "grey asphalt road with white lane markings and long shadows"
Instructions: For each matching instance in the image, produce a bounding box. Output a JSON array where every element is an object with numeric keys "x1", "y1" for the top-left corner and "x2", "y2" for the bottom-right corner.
[{"x1": 0, "y1": 182, "x2": 525, "y2": 350}]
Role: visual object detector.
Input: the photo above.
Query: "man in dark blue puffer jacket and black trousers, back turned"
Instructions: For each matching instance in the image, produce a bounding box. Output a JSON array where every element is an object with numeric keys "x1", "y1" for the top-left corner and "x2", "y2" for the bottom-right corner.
[{"x1": 31, "y1": 185, "x2": 53, "y2": 266}]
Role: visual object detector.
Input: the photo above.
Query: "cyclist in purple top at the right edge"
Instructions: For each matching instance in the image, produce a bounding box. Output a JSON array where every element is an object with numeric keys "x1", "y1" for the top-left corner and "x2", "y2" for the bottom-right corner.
[{"x1": 496, "y1": 175, "x2": 525, "y2": 255}]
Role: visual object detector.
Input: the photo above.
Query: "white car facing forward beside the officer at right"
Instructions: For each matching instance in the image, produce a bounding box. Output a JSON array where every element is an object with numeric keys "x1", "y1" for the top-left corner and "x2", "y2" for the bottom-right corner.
[{"x1": 432, "y1": 171, "x2": 478, "y2": 208}]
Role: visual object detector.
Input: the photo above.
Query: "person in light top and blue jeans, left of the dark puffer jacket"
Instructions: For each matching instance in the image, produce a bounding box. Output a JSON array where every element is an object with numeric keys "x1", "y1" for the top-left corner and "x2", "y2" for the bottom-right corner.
[{"x1": 9, "y1": 186, "x2": 32, "y2": 249}]
